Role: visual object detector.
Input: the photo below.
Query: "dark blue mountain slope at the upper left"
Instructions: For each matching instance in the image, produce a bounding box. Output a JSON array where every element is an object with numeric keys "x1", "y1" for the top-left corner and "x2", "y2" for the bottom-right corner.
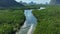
[{"x1": 0, "y1": 0, "x2": 24, "y2": 7}]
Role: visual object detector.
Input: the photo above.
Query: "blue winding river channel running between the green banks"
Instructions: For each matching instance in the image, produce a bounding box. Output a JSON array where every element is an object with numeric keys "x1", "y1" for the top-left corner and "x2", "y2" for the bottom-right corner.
[{"x1": 16, "y1": 10, "x2": 37, "y2": 34}]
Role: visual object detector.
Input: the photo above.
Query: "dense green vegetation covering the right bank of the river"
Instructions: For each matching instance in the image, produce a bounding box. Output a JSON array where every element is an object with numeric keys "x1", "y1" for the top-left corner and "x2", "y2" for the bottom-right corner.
[{"x1": 33, "y1": 6, "x2": 60, "y2": 34}]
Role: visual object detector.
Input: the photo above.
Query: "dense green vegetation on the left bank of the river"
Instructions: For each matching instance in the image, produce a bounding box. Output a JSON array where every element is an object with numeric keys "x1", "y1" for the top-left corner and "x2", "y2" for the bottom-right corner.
[{"x1": 0, "y1": 9, "x2": 25, "y2": 34}]
